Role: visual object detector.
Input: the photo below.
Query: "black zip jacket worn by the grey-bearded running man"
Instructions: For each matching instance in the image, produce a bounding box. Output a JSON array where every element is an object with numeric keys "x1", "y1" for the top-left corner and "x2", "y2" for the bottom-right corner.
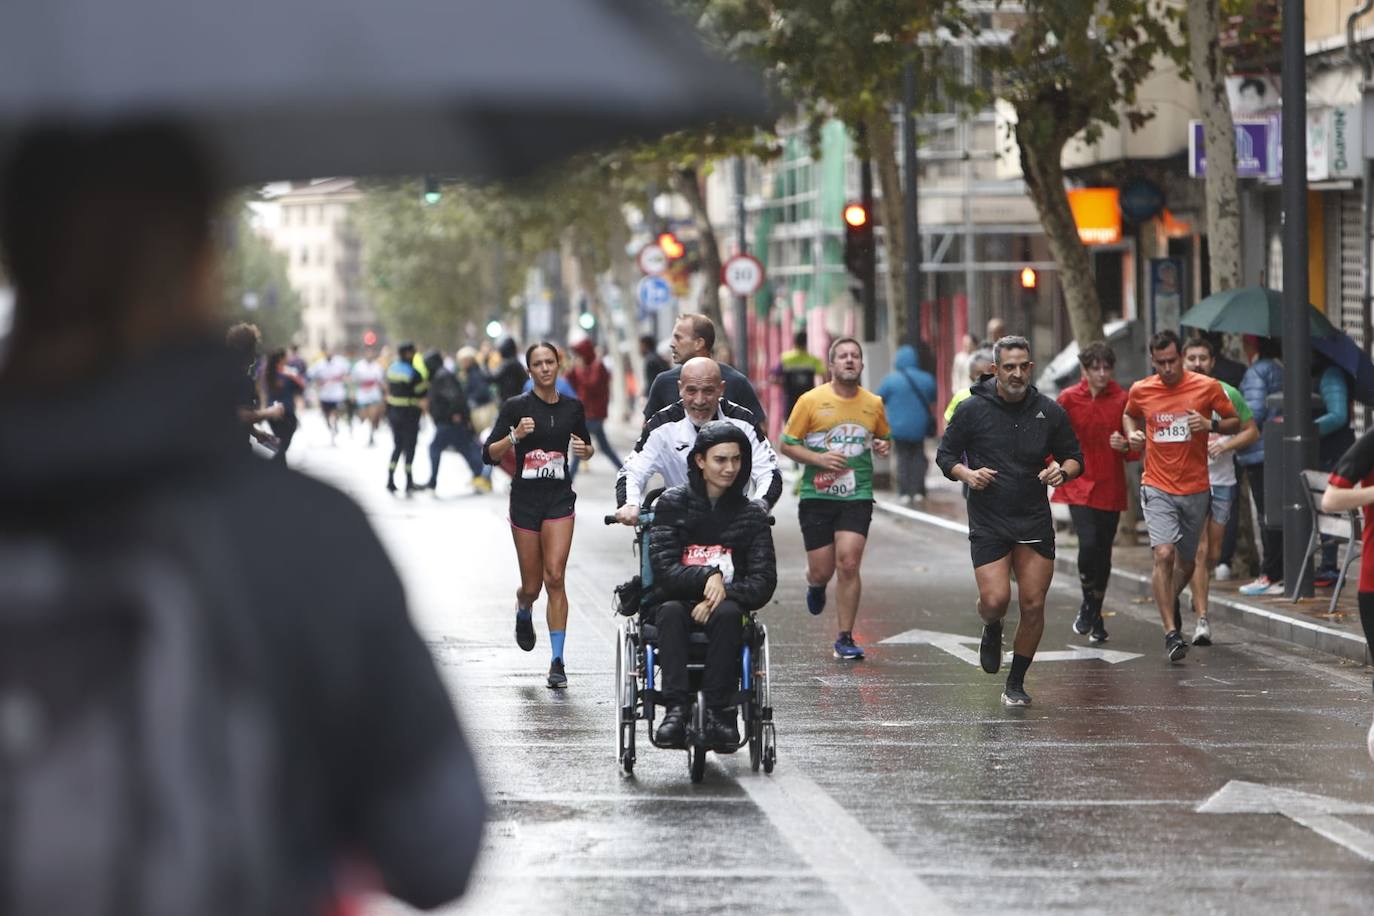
[{"x1": 936, "y1": 378, "x2": 1083, "y2": 541}]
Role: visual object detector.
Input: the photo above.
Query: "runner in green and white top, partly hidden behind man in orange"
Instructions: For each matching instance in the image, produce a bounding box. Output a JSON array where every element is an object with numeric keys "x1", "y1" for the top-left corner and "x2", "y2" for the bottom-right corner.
[{"x1": 1173, "y1": 336, "x2": 1260, "y2": 645}]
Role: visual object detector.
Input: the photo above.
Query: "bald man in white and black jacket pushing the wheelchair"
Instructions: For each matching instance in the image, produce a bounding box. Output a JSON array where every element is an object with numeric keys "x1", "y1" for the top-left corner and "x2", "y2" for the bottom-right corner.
[{"x1": 616, "y1": 357, "x2": 782, "y2": 525}]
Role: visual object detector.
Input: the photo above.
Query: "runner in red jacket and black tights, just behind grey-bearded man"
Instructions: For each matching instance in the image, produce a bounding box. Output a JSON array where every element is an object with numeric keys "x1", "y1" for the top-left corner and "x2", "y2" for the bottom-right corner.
[{"x1": 1050, "y1": 341, "x2": 1140, "y2": 643}]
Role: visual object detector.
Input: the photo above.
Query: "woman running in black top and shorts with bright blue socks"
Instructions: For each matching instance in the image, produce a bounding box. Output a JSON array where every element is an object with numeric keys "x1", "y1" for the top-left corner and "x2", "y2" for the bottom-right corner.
[{"x1": 482, "y1": 342, "x2": 592, "y2": 687}]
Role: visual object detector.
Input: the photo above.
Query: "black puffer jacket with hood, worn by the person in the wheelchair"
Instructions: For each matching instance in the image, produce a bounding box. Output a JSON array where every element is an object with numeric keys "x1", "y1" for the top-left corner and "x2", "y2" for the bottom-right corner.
[{"x1": 649, "y1": 420, "x2": 778, "y2": 611}]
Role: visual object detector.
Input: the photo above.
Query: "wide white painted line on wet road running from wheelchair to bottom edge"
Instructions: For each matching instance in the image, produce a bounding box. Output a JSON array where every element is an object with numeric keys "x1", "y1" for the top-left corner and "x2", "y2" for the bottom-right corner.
[{"x1": 736, "y1": 770, "x2": 952, "y2": 916}]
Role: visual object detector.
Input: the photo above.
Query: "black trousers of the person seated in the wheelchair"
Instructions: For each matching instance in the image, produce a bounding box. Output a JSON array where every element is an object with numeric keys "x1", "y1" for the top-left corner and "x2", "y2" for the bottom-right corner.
[{"x1": 654, "y1": 599, "x2": 745, "y2": 709}]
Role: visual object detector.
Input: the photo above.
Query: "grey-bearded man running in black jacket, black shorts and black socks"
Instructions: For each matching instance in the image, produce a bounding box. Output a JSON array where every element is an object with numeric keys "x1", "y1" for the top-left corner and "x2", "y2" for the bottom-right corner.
[{"x1": 936, "y1": 336, "x2": 1083, "y2": 706}]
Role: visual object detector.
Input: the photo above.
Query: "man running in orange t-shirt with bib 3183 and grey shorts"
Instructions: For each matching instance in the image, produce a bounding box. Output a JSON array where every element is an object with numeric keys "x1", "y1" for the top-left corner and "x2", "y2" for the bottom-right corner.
[{"x1": 1121, "y1": 331, "x2": 1241, "y2": 662}]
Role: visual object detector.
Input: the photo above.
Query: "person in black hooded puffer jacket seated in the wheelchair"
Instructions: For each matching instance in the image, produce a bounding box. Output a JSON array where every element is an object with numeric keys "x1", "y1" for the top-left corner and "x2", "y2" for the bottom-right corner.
[{"x1": 649, "y1": 420, "x2": 778, "y2": 753}]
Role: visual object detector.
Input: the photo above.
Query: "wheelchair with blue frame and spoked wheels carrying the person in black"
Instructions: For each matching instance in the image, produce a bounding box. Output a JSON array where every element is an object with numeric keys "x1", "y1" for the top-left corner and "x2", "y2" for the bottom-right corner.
[{"x1": 605, "y1": 488, "x2": 778, "y2": 783}]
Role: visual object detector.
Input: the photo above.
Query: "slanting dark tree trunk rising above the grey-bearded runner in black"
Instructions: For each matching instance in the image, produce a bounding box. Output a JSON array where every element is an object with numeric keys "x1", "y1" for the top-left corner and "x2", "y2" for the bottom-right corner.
[{"x1": 1017, "y1": 108, "x2": 1103, "y2": 346}]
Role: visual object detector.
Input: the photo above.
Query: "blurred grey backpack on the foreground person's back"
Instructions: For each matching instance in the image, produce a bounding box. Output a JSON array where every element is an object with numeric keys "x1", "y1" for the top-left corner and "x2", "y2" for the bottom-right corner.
[{"x1": 0, "y1": 492, "x2": 282, "y2": 916}]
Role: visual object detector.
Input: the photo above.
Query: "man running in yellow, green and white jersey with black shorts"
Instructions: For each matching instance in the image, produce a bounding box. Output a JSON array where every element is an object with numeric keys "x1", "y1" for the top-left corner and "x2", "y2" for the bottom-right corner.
[{"x1": 782, "y1": 338, "x2": 892, "y2": 661}]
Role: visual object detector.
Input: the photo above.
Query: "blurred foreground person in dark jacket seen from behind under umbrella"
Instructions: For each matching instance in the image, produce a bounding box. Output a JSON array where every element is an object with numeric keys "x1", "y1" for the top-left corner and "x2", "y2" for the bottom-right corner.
[{"x1": 0, "y1": 126, "x2": 485, "y2": 916}]
